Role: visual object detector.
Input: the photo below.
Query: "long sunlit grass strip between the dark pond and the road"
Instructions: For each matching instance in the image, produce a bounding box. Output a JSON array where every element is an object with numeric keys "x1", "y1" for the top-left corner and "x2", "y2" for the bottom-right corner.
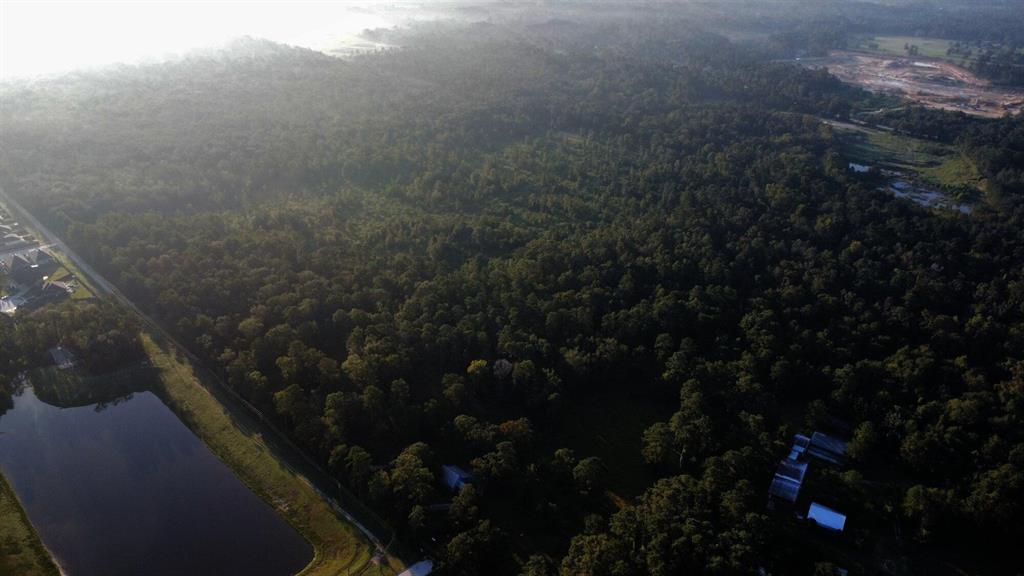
[{"x1": 142, "y1": 334, "x2": 396, "y2": 576}]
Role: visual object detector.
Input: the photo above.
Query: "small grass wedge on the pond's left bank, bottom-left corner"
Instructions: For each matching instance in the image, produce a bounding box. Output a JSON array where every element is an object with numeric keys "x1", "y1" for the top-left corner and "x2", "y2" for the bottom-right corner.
[{"x1": 0, "y1": 474, "x2": 60, "y2": 576}]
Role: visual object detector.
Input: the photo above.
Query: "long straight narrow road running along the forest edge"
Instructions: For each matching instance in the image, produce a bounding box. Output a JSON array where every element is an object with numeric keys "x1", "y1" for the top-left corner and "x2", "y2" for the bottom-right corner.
[{"x1": 0, "y1": 187, "x2": 405, "y2": 565}]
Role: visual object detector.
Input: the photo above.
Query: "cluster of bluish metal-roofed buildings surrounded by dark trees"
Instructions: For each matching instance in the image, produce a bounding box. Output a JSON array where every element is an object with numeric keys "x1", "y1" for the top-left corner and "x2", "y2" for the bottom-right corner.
[{"x1": 768, "y1": 431, "x2": 846, "y2": 532}]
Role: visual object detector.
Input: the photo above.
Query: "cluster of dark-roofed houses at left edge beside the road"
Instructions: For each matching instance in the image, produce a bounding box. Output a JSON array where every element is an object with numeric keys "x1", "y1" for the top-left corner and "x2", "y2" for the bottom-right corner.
[{"x1": 0, "y1": 248, "x2": 75, "y2": 314}]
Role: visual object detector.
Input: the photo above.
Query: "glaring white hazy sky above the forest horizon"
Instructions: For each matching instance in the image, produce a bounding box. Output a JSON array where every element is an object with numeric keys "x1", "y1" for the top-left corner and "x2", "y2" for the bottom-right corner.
[{"x1": 0, "y1": 0, "x2": 405, "y2": 78}]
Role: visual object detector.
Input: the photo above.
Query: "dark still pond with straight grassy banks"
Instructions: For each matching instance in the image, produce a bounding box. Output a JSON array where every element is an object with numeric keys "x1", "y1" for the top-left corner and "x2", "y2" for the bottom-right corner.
[{"x1": 0, "y1": 388, "x2": 312, "y2": 576}]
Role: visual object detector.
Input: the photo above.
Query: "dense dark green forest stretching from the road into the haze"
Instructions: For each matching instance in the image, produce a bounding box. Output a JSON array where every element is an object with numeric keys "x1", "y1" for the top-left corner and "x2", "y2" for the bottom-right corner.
[{"x1": 0, "y1": 3, "x2": 1024, "y2": 576}]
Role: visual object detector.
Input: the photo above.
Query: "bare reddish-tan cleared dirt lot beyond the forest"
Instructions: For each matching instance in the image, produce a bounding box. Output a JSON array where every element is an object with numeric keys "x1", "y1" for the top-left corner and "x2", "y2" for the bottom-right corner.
[{"x1": 807, "y1": 51, "x2": 1024, "y2": 118}]
